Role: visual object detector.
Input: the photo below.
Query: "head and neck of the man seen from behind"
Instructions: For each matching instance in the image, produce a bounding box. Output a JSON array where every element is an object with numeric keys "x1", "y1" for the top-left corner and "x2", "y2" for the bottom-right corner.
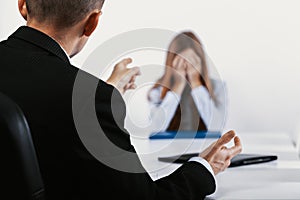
[{"x1": 18, "y1": 0, "x2": 105, "y2": 56}]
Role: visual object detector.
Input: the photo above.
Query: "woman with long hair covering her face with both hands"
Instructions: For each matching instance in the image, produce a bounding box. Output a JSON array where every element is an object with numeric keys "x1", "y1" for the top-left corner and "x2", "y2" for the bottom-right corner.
[{"x1": 148, "y1": 32, "x2": 226, "y2": 132}]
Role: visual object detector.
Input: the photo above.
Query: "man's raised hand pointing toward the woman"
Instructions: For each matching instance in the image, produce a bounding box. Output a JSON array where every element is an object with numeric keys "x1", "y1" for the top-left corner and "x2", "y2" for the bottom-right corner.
[{"x1": 106, "y1": 58, "x2": 141, "y2": 94}]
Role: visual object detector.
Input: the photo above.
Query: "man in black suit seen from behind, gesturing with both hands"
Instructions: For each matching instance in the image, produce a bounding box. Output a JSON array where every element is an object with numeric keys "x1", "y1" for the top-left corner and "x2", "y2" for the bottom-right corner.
[{"x1": 0, "y1": 0, "x2": 241, "y2": 200}]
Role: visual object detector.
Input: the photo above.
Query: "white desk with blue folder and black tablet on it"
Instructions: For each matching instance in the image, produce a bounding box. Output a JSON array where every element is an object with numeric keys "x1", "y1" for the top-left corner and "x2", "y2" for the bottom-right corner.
[{"x1": 132, "y1": 132, "x2": 300, "y2": 200}]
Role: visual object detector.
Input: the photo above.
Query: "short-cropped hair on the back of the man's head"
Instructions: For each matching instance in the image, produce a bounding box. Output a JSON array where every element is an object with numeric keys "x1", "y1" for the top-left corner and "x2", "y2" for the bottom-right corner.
[{"x1": 26, "y1": 0, "x2": 104, "y2": 28}]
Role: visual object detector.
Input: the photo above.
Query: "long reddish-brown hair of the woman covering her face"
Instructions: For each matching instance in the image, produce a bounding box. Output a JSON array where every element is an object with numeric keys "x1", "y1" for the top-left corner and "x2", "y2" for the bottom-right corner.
[{"x1": 153, "y1": 31, "x2": 216, "y2": 101}]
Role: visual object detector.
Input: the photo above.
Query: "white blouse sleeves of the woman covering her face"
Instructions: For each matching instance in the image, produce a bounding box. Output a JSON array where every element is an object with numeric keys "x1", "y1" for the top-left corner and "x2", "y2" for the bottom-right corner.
[{"x1": 149, "y1": 80, "x2": 227, "y2": 132}]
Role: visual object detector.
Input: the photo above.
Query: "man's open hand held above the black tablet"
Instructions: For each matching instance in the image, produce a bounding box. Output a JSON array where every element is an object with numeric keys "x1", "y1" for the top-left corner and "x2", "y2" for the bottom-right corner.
[{"x1": 199, "y1": 131, "x2": 242, "y2": 175}]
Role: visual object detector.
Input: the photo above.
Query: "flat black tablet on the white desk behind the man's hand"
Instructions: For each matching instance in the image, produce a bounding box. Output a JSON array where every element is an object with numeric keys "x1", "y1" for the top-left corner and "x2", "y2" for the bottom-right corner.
[{"x1": 158, "y1": 153, "x2": 278, "y2": 167}]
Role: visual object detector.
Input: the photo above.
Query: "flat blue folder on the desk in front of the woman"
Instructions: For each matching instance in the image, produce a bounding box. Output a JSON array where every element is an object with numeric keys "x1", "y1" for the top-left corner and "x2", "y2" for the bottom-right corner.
[{"x1": 149, "y1": 131, "x2": 222, "y2": 140}]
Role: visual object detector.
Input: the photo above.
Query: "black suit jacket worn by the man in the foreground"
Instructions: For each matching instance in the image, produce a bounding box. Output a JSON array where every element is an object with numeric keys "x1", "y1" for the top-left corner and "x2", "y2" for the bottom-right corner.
[{"x1": 0, "y1": 26, "x2": 215, "y2": 200}]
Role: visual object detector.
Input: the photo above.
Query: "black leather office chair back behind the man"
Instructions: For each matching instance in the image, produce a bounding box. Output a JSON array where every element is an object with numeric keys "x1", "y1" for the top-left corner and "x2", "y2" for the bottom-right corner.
[{"x1": 0, "y1": 93, "x2": 45, "y2": 200}]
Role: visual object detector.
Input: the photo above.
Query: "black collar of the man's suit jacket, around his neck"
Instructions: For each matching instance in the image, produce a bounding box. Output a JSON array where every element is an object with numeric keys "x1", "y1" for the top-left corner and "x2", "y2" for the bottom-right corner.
[{"x1": 10, "y1": 26, "x2": 71, "y2": 64}]
